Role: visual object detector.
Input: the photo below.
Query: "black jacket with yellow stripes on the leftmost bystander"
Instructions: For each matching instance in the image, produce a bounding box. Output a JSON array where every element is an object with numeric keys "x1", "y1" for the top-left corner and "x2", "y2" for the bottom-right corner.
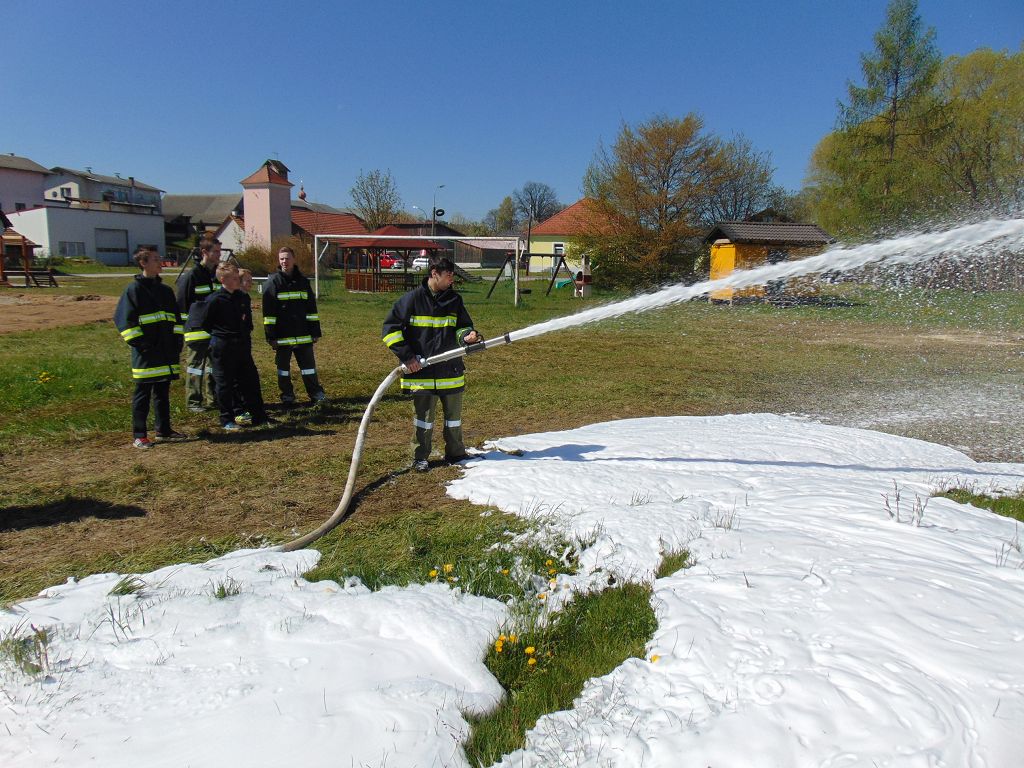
[{"x1": 114, "y1": 274, "x2": 184, "y2": 382}]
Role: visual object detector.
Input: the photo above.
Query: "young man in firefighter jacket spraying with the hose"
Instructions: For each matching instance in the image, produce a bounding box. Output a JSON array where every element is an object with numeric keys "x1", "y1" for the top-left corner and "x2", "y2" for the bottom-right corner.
[{"x1": 381, "y1": 255, "x2": 483, "y2": 472}]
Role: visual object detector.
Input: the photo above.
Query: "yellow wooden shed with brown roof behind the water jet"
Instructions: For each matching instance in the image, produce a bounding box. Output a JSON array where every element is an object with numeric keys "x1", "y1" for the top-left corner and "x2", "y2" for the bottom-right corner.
[{"x1": 703, "y1": 211, "x2": 836, "y2": 301}]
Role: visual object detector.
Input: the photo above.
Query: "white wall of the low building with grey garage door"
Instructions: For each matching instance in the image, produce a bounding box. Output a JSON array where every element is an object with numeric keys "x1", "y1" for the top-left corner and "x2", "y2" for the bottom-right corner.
[{"x1": 8, "y1": 207, "x2": 165, "y2": 266}]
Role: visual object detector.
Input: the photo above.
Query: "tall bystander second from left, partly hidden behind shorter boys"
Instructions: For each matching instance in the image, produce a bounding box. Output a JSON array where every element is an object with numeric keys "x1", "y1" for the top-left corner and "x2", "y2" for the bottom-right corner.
[{"x1": 177, "y1": 239, "x2": 220, "y2": 414}]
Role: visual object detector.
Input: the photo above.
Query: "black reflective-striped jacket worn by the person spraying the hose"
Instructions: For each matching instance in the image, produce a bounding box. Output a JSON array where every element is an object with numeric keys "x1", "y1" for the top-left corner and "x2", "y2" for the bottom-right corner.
[{"x1": 382, "y1": 278, "x2": 473, "y2": 393}]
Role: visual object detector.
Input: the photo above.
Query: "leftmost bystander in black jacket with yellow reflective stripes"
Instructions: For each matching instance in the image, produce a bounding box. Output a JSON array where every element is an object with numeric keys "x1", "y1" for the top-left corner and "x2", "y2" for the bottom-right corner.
[{"x1": 114, "y1": 246, "x2": 185, "y2": 449}]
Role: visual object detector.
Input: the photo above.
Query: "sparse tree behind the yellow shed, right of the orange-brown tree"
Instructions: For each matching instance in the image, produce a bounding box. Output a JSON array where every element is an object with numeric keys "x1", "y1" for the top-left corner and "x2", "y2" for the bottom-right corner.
[{"x1": 700, "y1": 135, "x2": 785, "y2": 227}]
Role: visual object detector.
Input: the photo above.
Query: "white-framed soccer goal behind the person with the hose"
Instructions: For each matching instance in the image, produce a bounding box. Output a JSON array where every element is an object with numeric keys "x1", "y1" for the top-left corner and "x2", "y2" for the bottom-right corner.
[{"x1": 313, "y1": 233, "x2": 526, "y2": 305}]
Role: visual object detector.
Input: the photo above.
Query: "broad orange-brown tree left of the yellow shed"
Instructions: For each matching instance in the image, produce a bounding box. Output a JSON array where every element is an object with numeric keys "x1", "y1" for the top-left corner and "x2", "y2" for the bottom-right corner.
[{"x1": 579, "y1": 113, "x2": 724, "y2": 288}]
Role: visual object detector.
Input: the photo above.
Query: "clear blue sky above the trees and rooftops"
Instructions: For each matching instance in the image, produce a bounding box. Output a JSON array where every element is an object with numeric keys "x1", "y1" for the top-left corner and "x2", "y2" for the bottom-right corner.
[{"x1": 8, "y1": 0, "x2": 1024, "y2": 218}]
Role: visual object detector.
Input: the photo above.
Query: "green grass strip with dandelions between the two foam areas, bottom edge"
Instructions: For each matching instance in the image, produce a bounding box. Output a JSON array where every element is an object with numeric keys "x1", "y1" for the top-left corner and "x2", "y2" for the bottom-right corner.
[{"x1": 465, "y1": 584, "x2": 657, "y2": 765}]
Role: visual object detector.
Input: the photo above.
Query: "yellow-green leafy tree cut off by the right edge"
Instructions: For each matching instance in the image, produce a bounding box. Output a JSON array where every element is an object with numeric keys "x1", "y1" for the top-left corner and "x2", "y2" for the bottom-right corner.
[{"x1": 926, "y1": 47, "x2": 1024, "y2": 212}]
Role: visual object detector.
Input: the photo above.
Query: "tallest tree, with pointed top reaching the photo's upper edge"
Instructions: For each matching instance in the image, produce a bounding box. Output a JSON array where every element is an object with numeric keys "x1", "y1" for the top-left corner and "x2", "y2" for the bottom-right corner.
[{"x1": 810, "y1": 0, "x2": 946, "y2": 233}]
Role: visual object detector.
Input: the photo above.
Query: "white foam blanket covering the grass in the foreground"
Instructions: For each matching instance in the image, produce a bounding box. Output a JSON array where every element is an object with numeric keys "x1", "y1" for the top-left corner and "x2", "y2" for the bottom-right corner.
[{"x1": 0, "y1": 415, "x2": 1024, "y2": 768}]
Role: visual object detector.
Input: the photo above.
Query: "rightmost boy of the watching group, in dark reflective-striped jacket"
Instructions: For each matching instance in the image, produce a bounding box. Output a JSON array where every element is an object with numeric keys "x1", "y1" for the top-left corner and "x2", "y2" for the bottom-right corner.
[{"x1": 263, "y1": 246, "x2": 327, "y2": 406}]
